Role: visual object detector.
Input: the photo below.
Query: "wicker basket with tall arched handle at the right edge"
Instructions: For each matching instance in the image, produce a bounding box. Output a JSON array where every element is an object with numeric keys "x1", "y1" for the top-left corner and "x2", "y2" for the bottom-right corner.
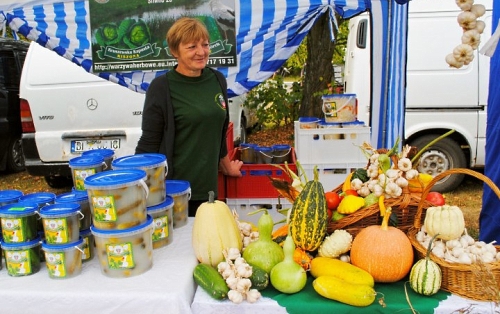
[{"x1": 408, "y1": 168, "x2": 500, "y2": 302}]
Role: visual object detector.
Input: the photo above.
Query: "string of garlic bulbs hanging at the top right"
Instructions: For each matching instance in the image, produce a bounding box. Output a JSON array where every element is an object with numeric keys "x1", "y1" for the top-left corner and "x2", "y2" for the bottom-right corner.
[{"x1": 446, "y1": 0, "x2": 486, "y2": 69}]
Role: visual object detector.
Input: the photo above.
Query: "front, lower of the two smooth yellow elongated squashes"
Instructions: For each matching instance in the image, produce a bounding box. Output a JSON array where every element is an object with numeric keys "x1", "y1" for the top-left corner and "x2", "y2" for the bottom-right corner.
[{"x1": 313, "y1": 276, "x2": 377, "y2": 306}]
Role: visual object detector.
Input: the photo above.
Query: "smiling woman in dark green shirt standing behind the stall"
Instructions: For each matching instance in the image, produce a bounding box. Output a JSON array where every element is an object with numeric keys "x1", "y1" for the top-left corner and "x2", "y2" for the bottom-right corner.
[{"x1": 135, "y1": 17, "x2": 243, "y2": 216}]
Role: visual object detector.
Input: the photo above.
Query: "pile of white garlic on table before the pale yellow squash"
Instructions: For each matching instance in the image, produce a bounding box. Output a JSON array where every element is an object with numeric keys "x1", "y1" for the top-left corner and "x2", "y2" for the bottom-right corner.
[{"x1": 217, "y1": 248, "x2": 261, "y2": 303}]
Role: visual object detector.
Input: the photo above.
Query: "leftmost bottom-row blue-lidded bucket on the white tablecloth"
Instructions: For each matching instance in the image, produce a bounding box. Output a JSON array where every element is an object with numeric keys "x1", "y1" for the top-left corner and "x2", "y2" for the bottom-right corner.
[{"x1": 1, "y1": 237, "x2": 41, "y2": 277}]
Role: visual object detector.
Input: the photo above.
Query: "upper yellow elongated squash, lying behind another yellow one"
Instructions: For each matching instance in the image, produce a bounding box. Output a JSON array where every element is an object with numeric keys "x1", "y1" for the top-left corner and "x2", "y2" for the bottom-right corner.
[{"x1": 310, "y1": 257, "x2": 375, "y2": 287}]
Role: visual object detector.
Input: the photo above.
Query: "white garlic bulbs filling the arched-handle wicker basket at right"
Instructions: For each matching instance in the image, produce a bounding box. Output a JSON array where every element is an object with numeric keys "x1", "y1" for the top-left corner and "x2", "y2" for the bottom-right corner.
[{"x1": 416, "y1": 226, "x2": 500, "y2": 265}]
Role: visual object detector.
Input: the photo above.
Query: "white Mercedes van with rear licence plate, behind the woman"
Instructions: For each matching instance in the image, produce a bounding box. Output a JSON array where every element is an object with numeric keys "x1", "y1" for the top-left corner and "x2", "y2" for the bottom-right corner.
[{"x1": 20, "y1": 42, "x2": 254, "y2": 187}]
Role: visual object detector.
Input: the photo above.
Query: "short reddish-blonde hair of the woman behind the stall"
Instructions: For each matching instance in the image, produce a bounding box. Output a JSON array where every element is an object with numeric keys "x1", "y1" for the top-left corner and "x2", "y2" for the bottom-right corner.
[{"x1": 167, "y1": 17, "x2": 210, "y2": 53}]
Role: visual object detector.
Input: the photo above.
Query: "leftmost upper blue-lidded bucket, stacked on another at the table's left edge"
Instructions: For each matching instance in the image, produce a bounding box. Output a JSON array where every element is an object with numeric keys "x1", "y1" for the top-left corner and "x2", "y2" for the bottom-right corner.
[{"x1": 0, "y1": 201, "x2": 39, "y2": 243}]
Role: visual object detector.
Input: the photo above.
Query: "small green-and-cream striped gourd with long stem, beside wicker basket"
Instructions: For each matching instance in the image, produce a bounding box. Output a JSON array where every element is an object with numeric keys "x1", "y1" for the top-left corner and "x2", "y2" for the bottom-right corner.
[{"x1": 410, "y1": 236, "x2": 442, "y2": 295}]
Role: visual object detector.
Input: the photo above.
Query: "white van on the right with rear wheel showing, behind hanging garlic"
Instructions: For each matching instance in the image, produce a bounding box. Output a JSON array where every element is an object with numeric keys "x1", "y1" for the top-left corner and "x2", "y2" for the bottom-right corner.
[{"x1": 344, "y1": 0, "x2": 492, "y2": 192}]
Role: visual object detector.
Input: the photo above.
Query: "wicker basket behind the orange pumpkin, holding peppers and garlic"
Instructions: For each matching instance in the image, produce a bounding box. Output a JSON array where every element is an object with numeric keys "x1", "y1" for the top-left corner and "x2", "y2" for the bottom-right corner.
[{"x1": 328, "y1": 185, "x2": 432, "y2": 237}]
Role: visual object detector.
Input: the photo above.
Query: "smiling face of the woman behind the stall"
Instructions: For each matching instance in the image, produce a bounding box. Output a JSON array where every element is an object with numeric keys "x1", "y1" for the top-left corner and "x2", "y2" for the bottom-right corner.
[{"x1": 174, "y1": 39, "x2": 210, "y2": 76}]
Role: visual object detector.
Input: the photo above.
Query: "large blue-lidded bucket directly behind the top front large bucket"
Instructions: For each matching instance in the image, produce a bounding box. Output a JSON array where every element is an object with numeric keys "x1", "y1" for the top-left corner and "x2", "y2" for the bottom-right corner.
[{"x1": 111, "y1": 154, "x2": 168, "y2": 206}]
